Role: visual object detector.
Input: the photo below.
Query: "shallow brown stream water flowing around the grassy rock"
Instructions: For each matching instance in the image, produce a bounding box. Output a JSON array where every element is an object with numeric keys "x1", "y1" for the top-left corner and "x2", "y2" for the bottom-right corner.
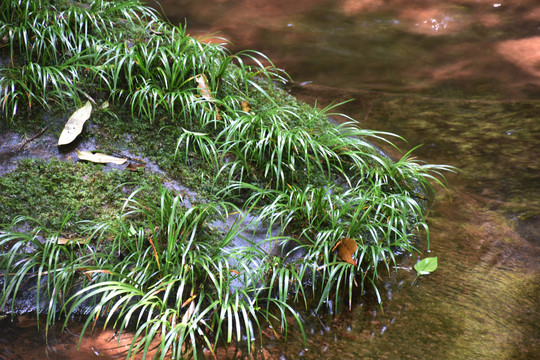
[{"x1": 0, "y1": 0, "x2": 540, "y2": 359}]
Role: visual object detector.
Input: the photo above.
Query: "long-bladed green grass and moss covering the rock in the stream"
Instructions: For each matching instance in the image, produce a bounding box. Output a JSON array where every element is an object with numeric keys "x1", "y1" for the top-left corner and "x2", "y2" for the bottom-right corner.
[{"x1": 0, "y1": 0, "x2": 453, "y2": 358}]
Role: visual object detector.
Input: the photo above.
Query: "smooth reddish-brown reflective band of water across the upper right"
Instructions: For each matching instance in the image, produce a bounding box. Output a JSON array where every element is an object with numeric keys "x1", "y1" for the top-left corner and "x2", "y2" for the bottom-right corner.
[{"x1": 160, "y1": 0, "x2": 540, "y2": 97}]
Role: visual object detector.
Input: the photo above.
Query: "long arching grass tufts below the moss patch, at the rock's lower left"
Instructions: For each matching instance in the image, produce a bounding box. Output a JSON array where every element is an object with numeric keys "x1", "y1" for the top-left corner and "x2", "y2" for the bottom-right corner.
[{"x1": 0, "y1": 189, "x2": 299, "y2": 358}]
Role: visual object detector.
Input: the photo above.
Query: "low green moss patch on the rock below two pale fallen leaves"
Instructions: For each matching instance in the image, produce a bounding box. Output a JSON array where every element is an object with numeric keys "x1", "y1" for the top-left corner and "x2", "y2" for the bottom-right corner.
[{"x1": 0, "y1": 158, "x2": 160, "y2": 233}]
